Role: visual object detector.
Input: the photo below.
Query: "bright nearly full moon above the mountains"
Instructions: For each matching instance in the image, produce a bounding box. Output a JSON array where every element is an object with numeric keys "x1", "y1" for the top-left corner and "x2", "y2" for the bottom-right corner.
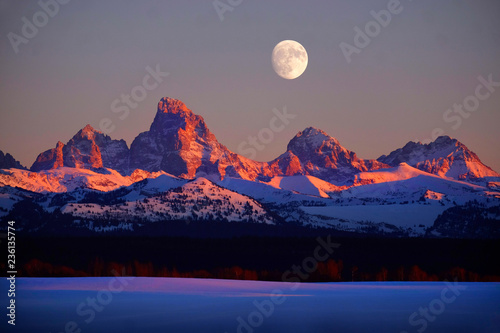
[{"x1": 272, "y1": 40, "x2": 308, "y2": 80}]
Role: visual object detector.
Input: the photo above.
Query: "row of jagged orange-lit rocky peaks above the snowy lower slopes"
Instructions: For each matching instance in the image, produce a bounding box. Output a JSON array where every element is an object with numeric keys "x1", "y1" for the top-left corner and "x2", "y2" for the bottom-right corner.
[{"x1": 24, "y1": 97, "x2": 499, "y2": 184}]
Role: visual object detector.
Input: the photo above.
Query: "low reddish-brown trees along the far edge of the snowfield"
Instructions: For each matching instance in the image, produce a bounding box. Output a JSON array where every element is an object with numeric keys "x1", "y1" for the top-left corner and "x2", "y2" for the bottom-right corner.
[{"x1": 8, "y1": 257, "x2": 500, "y2": 282}]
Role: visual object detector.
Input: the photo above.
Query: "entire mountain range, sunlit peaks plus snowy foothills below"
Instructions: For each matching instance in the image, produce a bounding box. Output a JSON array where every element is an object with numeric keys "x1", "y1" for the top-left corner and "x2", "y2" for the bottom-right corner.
[{"x1": 0, "y1": 97, "x2": 500, "y2": 237}]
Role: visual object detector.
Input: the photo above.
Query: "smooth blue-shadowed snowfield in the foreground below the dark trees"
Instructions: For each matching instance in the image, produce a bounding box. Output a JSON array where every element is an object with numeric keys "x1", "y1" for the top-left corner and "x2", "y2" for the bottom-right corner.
[{"x1": 0, "y1": 277, "x2": 500, "y2": 333}]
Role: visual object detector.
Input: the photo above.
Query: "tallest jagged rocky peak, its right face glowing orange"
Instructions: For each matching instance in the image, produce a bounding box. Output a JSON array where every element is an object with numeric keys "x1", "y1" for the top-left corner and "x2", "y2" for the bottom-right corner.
[{"x1": 130, "y1": 97, "x2": 260, "y2": 179}]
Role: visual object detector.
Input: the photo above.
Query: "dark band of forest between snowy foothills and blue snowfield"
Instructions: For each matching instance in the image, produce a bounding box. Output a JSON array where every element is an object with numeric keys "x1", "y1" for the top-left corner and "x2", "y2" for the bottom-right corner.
[{"x1": 4, "y1": 235, "x2": 500, "y2": 282}]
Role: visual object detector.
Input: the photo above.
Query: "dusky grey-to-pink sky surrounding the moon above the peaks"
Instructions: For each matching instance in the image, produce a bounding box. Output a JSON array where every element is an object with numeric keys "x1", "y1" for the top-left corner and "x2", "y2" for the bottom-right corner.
[{"x1": 0, "y1": 0, "x2": 500, "y2": 171}]
